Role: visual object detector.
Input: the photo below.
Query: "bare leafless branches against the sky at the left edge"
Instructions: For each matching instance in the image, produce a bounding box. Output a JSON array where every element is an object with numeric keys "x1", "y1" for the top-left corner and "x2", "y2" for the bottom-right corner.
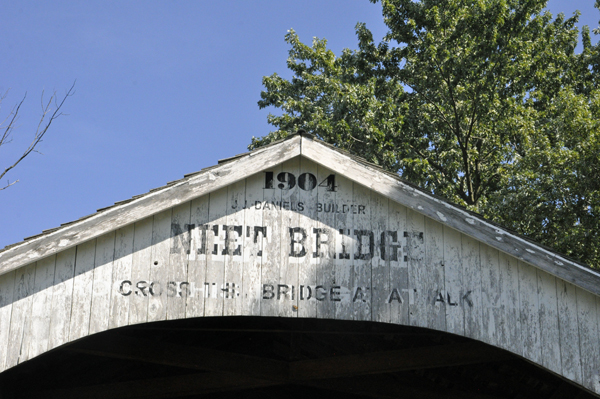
[{"x1": 0, "y1": 83, "x2": 75, "y2": 191}]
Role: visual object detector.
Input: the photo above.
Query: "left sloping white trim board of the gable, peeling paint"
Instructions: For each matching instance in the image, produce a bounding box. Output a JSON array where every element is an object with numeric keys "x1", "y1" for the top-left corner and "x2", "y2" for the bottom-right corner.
[{"x1": 0, "y1": 136, "x2": 300, "y2": 274}]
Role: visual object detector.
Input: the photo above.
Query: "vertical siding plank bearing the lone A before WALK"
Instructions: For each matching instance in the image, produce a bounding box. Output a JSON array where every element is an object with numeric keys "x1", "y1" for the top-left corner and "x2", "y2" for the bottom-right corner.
[{"x1": 386, "y1": 201, "x2": 409, "y2": 325}]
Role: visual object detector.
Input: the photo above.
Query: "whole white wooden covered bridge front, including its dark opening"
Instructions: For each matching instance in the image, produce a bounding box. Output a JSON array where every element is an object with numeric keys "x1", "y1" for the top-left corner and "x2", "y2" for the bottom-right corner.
[{"x1": 0, "y1": 134, "x2": 600, "y2": 399}]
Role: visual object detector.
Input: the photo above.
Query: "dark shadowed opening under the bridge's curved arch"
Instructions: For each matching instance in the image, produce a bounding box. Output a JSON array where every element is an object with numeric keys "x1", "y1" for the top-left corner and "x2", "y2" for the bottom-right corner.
[{"x1": 0, "y1": 317, "x2": 596, "y2": 399}]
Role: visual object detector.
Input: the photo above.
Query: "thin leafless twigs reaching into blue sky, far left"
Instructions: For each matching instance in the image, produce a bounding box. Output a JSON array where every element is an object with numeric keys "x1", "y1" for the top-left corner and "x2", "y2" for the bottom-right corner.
[{"x1": 0, "y1": 82, "x2": 75, "y2": 191}]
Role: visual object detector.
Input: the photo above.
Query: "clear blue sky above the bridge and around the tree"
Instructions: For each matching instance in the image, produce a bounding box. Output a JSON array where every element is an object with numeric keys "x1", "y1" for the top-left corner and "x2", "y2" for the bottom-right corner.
[{"x1": 0, "y1": 0, "x2": 600, "y2": 248}]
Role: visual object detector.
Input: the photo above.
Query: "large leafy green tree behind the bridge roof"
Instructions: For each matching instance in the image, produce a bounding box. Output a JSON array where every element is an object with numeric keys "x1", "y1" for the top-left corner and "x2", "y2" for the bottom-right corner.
[{"x1": 249, "y1": 0, "x2": 600, "y2": 265}]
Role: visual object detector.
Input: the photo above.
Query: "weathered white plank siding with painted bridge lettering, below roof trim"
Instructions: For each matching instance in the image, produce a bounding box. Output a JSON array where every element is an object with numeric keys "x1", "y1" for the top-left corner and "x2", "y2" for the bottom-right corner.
[{"x1": 0, "y1": 157, "x2": 600, "y2": 393}]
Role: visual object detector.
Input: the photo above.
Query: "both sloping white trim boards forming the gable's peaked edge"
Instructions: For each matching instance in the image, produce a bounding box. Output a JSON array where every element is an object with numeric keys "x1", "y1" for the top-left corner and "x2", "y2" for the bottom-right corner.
[{"x1": 0, "y1": 134, "x2": 600, "y2": 295}]
